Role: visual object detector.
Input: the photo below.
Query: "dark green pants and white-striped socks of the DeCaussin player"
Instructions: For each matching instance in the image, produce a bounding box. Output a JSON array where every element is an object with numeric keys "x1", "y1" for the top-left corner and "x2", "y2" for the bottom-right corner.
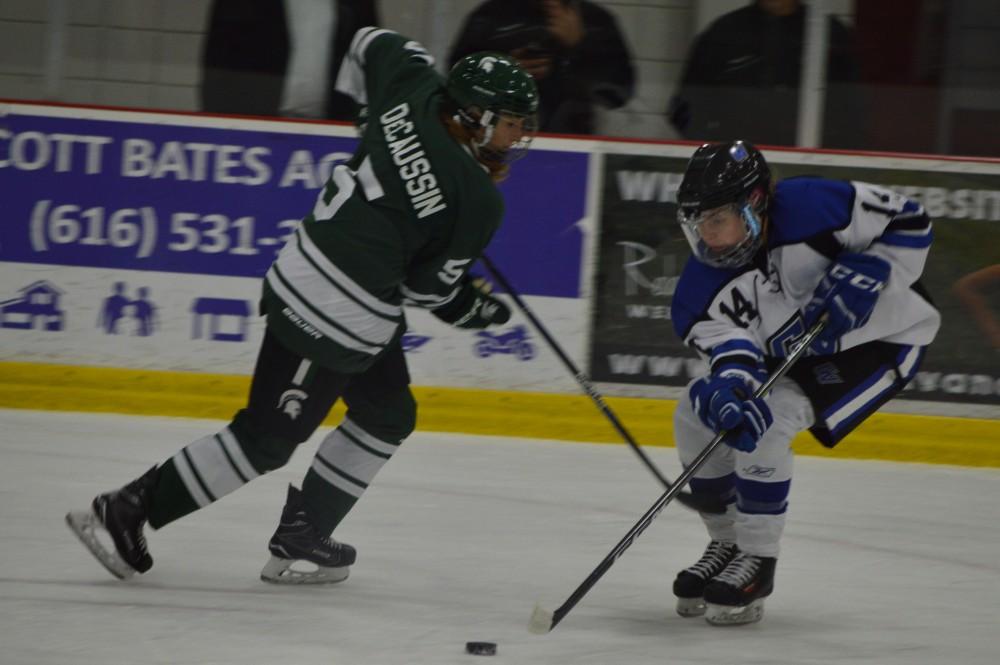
[{"x1": 149, "y1": 332, "x2": 416, "y2": 534}]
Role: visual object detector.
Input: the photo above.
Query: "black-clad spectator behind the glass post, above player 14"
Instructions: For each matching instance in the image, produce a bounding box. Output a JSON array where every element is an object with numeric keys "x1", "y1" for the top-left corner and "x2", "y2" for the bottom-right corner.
[{"x1": 667, "y1": 0, "x2": 866, "y2": 148}]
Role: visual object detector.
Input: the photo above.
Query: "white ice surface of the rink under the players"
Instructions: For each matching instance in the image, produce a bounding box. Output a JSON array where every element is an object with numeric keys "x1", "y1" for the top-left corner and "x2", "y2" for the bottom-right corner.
[{"x1": 0, "y1": 410, "x2": 1000, "y2": 665}]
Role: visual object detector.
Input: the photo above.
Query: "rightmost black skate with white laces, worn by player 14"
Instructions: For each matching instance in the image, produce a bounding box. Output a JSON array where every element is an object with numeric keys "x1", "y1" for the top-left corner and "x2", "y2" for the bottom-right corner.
[{"x1": 705, "y1": 553, "x2": 778, "y2": 626}]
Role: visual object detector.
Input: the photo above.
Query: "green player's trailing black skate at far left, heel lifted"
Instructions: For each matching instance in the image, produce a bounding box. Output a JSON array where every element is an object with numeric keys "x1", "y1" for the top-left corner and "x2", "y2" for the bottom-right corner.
[{"x1": 66, "y1": 466, "x2": 157, "y2": 580}]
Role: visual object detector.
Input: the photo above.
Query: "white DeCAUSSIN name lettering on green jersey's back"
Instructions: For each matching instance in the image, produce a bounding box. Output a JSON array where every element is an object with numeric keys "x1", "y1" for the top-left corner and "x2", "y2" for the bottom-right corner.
[{"x1": 379, "y1": 102, "x2": 448, "y2": 219}]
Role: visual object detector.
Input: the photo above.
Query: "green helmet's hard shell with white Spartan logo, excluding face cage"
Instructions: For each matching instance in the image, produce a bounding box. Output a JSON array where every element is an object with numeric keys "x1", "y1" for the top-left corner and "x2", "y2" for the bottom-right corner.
[{"x1": 446, "y1": 53, "x2": 538, "y2": 116}]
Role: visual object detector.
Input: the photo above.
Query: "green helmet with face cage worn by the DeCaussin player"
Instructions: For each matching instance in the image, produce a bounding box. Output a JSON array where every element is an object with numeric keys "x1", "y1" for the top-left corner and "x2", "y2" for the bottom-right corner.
[{"x1": 445, "y1": 53, "x2": 538, "y2": 164}]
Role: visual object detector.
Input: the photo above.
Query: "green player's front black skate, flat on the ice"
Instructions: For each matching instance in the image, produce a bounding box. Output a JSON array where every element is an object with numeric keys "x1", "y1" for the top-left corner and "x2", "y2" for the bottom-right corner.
[{"x1": 260, "y1": 485, "x2": 357, "y2": 584}]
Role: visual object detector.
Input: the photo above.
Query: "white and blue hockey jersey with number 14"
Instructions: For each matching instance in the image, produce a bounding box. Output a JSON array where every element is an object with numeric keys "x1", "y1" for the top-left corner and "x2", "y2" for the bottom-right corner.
[{"x1": 671, "y1": 177, "x2": 941, "y2": 376}]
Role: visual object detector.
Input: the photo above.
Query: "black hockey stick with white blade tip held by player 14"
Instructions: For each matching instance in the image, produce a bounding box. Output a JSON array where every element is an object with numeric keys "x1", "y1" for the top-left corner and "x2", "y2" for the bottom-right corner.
[{"x1": 528, "y1": 315, "x2": 826, "y2": 635}]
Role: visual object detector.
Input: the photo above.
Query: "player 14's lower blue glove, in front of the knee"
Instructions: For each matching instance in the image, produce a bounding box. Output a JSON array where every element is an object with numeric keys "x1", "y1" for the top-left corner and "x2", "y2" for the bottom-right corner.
[{"x1": 689, "y1": 375, "x2": 774, "y2": 453}]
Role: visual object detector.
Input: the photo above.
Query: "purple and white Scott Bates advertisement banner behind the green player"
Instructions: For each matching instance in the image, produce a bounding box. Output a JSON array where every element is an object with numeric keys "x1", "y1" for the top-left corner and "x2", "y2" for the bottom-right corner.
[{"x1": 0, "y1": 105, "x2": 590, "y2": 391}]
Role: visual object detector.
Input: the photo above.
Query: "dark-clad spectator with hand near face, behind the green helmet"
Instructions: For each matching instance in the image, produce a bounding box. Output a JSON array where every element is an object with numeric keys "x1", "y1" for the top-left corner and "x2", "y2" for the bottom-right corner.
[{"x1": 448, "y1": 0, "x2": 635, "y2": 134}]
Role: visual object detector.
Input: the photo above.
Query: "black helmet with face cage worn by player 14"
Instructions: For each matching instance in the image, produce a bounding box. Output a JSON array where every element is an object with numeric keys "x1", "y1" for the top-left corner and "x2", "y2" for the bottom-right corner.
[{"x1": 677, "y1": 141, "x2": 771, "y2": 268}]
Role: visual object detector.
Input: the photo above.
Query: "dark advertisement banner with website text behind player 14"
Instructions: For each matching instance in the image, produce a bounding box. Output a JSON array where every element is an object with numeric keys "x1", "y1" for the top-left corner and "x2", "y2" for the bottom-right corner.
[{"x1": 590, "y1": 147, "x2": 1000, "y2": 404}]
